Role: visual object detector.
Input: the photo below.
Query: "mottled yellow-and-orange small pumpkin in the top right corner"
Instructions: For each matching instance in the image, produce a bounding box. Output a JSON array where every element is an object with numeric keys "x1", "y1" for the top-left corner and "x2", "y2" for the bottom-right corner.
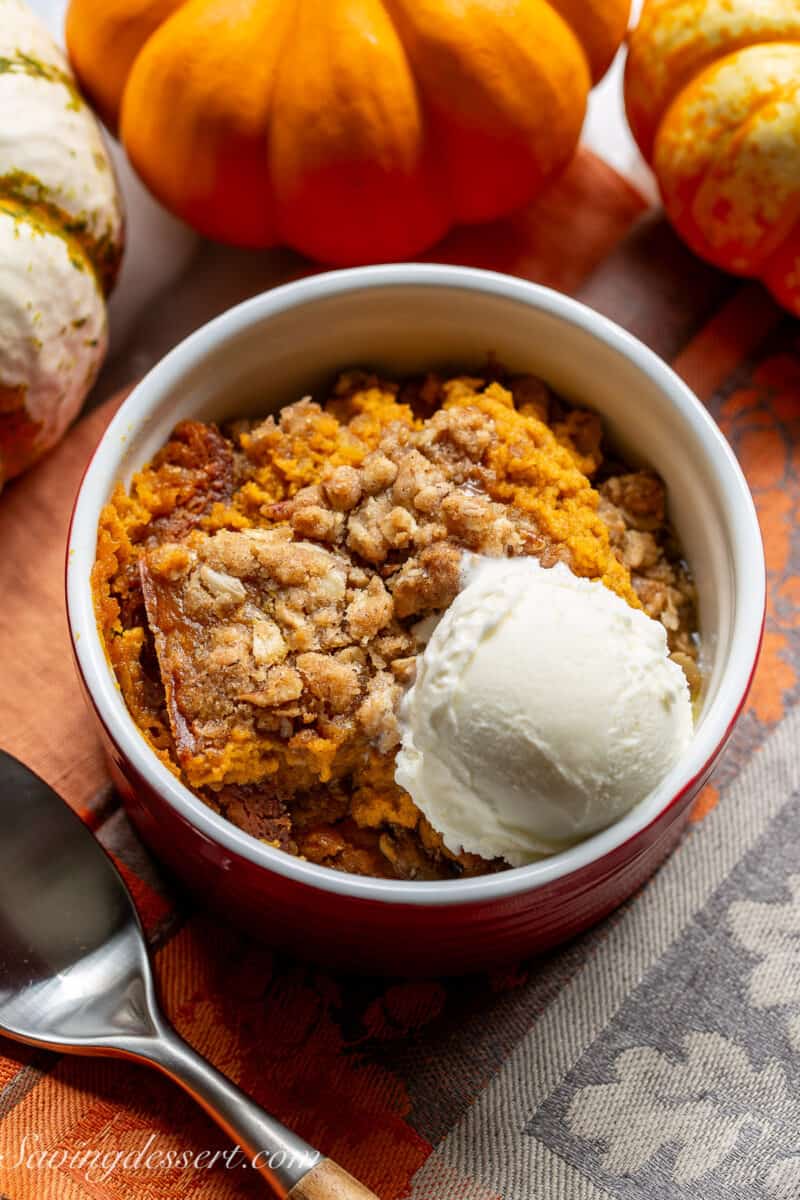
[{"x1": 625, "y1": 0, "x2": 800, "y2": 313}]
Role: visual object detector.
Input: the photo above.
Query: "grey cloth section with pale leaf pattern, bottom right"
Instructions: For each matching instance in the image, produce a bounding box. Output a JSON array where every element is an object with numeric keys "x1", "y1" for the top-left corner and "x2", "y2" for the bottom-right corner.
[{"x1": 413, "y1": 709, "x2": 800, "y2": 1200}]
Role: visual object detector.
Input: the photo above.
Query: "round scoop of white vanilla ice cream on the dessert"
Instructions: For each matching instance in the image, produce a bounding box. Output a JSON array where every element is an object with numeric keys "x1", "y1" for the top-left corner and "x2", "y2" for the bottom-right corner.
[{"x1": 396, "y1": 554, "x2": 692, "y2": 866}]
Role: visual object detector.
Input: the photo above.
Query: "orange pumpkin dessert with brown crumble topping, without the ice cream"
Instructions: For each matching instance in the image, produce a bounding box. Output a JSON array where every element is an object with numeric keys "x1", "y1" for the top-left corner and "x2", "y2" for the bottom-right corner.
[{"x1": 94, "y1": 367, "x2": 699, "y2": 880}]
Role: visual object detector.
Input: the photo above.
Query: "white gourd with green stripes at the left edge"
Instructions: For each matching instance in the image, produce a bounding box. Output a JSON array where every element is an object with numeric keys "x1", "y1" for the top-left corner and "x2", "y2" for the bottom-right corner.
[{"x1": 0, "y1": 0, "x2": 124, "y2": 487}]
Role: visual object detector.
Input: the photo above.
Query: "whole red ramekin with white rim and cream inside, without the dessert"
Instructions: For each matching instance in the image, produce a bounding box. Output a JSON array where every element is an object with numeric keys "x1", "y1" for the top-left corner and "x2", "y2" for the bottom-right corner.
[{"x1": 67, "y1": 264, "x2": 765, "y2": 976}]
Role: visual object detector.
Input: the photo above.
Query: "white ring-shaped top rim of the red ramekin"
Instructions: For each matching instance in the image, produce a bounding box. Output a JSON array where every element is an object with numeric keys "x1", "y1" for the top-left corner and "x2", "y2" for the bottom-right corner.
[{"x1": 66, "y1": 263, "x2": 766, "y2": 906}]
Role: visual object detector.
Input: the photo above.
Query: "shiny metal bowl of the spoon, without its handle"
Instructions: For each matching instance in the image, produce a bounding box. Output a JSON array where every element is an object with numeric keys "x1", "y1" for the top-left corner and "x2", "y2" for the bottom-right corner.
[{"x1": 0, "y1": 755, "x2": 158, "y2": 1054}]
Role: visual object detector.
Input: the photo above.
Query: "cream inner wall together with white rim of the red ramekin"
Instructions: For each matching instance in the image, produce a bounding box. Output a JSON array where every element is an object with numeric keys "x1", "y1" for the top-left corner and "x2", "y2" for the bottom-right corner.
[{"x1": 68, "y1": 266, "x2": 763, "y2": 900}]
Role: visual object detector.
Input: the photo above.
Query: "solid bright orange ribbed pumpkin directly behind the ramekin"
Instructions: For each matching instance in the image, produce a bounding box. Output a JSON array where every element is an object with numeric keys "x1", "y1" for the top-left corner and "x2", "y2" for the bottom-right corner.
[{"x1": 67, "y1": 0, "x2": 630, "y2": 264}]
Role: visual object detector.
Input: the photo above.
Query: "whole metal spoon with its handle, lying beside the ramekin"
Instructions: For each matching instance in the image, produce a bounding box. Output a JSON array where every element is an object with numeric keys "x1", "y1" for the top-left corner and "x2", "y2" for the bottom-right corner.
[{"x1": 0, "y1": 750, "x2": 377, "y2": 1200}]
